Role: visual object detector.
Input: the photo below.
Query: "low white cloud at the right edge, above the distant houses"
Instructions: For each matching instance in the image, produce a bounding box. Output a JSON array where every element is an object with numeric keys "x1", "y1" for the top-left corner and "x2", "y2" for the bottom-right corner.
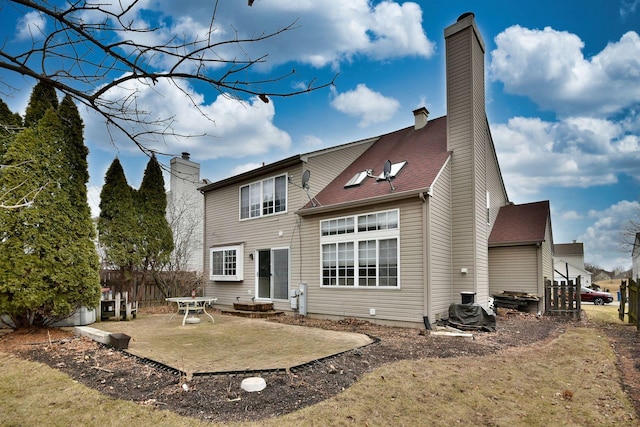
[{"x1": 578, "y1": 200, "x2": 640, "y2": 269}]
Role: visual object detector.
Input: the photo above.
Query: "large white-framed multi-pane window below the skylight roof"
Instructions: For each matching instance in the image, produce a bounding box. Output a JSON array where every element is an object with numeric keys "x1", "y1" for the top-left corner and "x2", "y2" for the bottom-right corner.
[{"x1": 320, "y1": 209, "x2": 400, "y2": 288}]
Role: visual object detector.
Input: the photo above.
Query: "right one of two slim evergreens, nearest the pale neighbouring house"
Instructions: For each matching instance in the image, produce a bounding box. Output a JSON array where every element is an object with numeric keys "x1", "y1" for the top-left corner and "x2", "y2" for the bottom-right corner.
[{"x1": 136, "y1": 155, "x2": 173, "y2": 271}]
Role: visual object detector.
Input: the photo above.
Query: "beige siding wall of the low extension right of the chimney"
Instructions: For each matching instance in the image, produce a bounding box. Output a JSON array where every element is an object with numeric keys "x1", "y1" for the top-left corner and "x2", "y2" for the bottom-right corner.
[{"x1": 489, "y1": 245, "x2": 539, "y2": 295}]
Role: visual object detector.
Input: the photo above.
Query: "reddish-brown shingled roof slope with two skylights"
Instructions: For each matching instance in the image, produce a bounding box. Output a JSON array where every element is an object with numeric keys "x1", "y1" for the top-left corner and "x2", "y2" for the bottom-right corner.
[{"x1": 301, "y1": 117, "x2": 449, "y2": 211}]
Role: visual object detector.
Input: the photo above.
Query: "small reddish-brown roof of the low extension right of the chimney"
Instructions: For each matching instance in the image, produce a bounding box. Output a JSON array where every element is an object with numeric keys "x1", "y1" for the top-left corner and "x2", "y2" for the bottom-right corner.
[{"x1": 489, "y1": 200, "x2": 550, "y2": 246}]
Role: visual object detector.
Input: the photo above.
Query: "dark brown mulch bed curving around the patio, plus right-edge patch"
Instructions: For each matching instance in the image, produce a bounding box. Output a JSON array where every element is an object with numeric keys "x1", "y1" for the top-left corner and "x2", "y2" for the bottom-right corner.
[{"x1": 0, "y1": 312, "x2": 640, "y2": 422}]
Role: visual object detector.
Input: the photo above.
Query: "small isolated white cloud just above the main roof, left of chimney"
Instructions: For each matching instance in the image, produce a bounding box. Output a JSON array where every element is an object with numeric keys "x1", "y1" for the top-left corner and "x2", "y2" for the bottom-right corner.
[{"x1": 331, "y1": 84, "x2": 400, "y2": 128}]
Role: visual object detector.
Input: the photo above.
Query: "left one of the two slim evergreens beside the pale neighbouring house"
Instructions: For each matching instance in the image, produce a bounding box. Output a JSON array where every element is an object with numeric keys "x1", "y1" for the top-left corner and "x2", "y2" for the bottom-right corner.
[{"x1": 98, "y1": 158, "x2": 141, "y2": 278}]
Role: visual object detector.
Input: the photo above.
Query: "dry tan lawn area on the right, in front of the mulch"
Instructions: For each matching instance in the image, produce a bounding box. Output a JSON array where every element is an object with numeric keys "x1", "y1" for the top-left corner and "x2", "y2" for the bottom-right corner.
[{"x1": 244, "y1": 327, "x2": 636, "y2": 427}]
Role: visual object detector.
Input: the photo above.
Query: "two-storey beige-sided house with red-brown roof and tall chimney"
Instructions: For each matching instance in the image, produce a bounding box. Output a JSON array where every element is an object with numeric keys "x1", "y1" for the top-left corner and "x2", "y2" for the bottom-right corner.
[{"x1": 201, "y1": 14, "x2": 553, "y2": 326}]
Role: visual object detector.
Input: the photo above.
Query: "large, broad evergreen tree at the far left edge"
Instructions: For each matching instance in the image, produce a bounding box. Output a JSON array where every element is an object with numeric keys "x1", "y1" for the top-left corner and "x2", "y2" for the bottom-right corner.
[{"x1": 0, "y1": 109, "x2": 100, "y2": 328}]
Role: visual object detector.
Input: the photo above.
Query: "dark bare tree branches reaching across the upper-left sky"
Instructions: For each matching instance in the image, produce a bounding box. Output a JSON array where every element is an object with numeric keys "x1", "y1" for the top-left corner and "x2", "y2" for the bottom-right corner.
[{"x1": 0, "y1": 0, "x2": 336, "y2": 155}]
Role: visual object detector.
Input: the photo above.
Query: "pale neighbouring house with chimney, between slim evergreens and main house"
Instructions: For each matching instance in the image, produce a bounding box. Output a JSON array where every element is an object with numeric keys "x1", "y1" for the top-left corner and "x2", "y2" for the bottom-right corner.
[{"x1": 167, "y1": 152, "x2": 209, "y2": 273}]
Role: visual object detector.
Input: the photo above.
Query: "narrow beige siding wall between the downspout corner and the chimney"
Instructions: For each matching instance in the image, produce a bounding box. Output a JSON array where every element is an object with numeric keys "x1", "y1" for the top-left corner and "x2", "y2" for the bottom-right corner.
[{"x1": 426, "y1": 162, "x2": 458, "y2": 320}]
